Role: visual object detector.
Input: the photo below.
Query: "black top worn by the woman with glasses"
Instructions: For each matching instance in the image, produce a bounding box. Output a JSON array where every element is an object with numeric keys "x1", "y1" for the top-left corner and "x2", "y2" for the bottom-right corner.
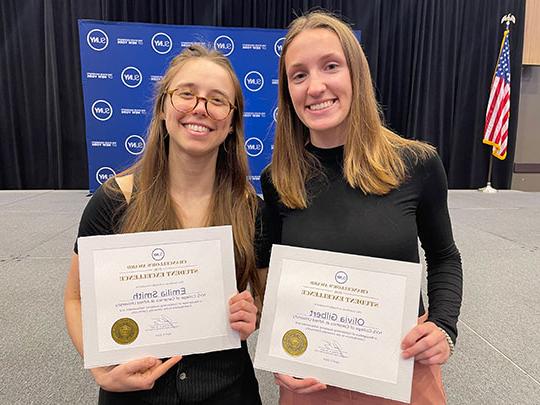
[{"x1": 74, "y1": 181, "x2": 268, "y2": 405}]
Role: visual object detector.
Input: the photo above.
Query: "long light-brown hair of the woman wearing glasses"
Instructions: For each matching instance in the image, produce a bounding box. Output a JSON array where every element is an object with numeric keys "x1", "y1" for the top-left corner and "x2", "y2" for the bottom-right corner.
[{"x1": 106, "y1": 45, "x2": 261, "y2": 295}]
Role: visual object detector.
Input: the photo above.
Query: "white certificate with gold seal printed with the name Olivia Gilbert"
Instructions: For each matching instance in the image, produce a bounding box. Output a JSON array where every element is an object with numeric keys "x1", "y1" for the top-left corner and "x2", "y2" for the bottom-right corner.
[{"x1": 254, "y1": 245, "x2": 422, "y2": 403}]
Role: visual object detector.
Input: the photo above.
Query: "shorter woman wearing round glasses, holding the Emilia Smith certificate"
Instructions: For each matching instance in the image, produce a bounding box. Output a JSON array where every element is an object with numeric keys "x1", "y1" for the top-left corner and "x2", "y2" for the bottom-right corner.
[{"x1": 64, "y1": 46, "x2": 261, "y2": 405}]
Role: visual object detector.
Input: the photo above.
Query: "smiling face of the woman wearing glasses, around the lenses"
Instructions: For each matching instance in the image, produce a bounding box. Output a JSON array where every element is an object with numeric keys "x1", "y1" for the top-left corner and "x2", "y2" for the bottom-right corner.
[{"x1": 163, "y1": 58, "x2": 235, "y2": 156}]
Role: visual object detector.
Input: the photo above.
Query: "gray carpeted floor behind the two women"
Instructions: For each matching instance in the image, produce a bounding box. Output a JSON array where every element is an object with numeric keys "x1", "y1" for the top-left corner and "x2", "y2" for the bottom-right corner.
[{"x1": 0, "y1": 191, "x2": 540, "y2": 405}]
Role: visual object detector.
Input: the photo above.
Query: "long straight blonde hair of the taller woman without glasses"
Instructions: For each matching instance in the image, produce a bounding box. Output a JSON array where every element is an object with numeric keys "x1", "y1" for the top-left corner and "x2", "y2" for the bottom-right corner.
[{"x1": 271, "y1": 11, "x2": 434, "y2": 208}]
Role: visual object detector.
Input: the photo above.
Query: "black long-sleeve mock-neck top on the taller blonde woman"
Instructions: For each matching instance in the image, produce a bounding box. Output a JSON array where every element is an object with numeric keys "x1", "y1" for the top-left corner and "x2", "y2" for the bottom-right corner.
[{"x1": 261, "y1": 145, "x2": 462, "y2": 342}]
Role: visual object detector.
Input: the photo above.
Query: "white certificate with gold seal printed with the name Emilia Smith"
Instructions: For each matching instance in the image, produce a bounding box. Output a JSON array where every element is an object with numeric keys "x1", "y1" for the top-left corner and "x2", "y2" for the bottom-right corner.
[{"x1": 78, "y1": 226, "x2": 240, "y2": 368}]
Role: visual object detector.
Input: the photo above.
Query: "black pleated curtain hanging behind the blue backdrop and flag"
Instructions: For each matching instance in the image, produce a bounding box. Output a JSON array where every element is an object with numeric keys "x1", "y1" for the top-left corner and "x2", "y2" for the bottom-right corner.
[{"x1": 0, "y1": 0, "x2": 525, "y2": 189}]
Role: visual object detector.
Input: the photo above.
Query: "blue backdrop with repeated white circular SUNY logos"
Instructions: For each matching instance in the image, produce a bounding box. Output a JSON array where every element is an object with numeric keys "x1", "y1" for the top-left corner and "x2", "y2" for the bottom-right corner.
[{"x1": 79, "y1": 20, "x2": 286, "y2": 193}]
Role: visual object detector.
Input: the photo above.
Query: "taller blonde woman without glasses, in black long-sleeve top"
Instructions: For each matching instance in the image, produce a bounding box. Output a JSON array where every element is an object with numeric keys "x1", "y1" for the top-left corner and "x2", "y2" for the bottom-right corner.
[{"x1": 261, "y1": 12, "x2": 462, "y2": 405}]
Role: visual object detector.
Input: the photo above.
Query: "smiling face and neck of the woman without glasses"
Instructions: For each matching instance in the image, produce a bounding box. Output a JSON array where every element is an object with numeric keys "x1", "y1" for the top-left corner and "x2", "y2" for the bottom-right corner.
[{"x1": 285, "y1": 28, "x2": 352, "y2": 148}]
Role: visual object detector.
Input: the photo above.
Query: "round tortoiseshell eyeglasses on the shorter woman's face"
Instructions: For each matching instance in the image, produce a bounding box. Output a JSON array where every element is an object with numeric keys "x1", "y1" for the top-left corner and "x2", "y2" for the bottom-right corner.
[{"x1": 166, "y1": 89, "x2": 236, "y2": 121}]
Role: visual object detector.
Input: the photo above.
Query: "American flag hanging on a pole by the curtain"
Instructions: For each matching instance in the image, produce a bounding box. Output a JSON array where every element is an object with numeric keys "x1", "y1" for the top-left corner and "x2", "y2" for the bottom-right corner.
[{"x1": 483, "y1": 29, "x2": 510, "y2": 160}]
